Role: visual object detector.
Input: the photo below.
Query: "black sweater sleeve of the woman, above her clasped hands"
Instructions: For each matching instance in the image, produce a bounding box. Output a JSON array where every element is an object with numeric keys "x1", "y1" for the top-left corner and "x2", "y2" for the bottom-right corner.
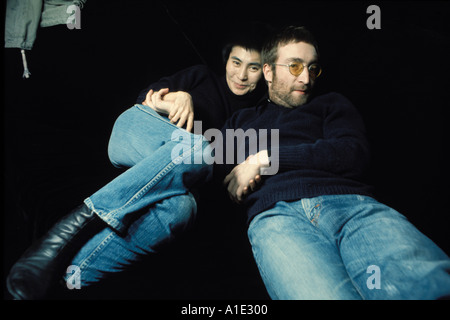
[{"x1": 136, "y1": 65, "x2": 209, "y2": 103}]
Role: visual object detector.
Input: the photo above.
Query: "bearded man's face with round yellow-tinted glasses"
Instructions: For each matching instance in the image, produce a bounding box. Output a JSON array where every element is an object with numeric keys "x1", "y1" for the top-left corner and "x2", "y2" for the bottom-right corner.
[{"x1": 264, "y1": 42, "x2": 318, "y2": 108}]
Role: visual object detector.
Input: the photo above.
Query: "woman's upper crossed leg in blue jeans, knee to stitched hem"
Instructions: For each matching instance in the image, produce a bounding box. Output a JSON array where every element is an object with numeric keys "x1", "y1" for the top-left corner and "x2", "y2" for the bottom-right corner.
[{"x1": 85, "y1": 105, "x2": 212, "y2": 232}]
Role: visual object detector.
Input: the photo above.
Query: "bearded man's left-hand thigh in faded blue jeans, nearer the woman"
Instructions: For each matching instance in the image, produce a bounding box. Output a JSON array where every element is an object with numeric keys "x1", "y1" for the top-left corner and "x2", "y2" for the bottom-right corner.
[{"x1": 248, "y1": 201, "x2": 361, "y2": 299}]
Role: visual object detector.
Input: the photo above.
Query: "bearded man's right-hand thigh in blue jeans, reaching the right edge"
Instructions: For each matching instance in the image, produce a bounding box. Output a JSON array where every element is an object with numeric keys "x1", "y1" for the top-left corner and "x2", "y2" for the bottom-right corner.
[{"x1": 334, "y1": 197, "x2": 450, "y2": 299}]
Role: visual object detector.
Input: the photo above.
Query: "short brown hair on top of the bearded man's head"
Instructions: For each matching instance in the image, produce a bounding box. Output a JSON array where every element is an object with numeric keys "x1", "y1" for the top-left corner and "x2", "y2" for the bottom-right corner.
[{"x1": 261, "y1": 26, "x2": 319, "y2": 65}]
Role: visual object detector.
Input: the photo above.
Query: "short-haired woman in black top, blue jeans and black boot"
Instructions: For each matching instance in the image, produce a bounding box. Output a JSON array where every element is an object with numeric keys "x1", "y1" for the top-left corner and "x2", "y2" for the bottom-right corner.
[{"x1": 7, "y1": 23, "x2": 266, "y2": 299}]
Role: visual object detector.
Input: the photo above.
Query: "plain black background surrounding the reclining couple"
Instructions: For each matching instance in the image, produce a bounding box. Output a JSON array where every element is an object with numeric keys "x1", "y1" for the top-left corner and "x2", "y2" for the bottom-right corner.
[{"x1": 2, "y1": 0, "x2": 450, "y2": 299}]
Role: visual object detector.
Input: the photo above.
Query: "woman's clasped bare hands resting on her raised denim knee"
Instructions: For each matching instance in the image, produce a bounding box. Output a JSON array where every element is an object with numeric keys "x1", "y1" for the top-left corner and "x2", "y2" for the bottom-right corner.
[{"x1": 142, "y1": 88, "x2": 194, "y2": 132}]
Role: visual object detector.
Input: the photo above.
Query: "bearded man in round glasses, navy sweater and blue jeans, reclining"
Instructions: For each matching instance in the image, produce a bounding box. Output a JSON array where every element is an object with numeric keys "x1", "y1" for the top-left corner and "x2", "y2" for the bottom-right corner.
[{"x1": 217, "y1": 27, "x2": 450, "y2": 299}]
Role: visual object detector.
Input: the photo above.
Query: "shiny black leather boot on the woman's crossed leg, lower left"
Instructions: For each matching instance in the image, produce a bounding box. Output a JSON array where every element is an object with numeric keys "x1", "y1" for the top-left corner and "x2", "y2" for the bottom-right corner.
[{"x1": 6, "y1": 204, "x2": 106, "y2": 300}]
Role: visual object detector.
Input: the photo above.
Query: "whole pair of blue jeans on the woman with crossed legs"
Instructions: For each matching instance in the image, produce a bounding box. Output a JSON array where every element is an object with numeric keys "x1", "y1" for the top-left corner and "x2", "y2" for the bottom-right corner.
[{"x1": 66, "y1": 105, "x2": 212, "y2": 285}]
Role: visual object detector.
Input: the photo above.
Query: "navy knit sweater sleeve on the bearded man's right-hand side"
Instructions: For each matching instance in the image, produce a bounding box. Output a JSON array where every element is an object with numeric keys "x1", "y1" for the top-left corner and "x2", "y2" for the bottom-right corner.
[{"x1": 270, "y1": 94, "x2": 370, "y2": 178}]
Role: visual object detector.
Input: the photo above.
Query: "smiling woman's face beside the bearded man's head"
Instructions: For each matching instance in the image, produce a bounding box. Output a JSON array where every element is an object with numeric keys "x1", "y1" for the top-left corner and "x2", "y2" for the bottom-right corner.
[{"x1": 226, "y1": 46, "x2": 262, "y2": 96}]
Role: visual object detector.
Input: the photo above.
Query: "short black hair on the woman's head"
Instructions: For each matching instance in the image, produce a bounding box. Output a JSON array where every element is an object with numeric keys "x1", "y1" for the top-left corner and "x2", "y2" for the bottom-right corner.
[{"x1": 222, "y1": 22, "x2": 272, "y2": 64}]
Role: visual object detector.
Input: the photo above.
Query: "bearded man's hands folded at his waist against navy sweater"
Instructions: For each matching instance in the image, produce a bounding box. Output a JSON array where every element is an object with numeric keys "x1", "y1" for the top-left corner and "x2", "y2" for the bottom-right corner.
[{"x1": 223, "y1": 150, "x2": 269, "y2": 203}]
